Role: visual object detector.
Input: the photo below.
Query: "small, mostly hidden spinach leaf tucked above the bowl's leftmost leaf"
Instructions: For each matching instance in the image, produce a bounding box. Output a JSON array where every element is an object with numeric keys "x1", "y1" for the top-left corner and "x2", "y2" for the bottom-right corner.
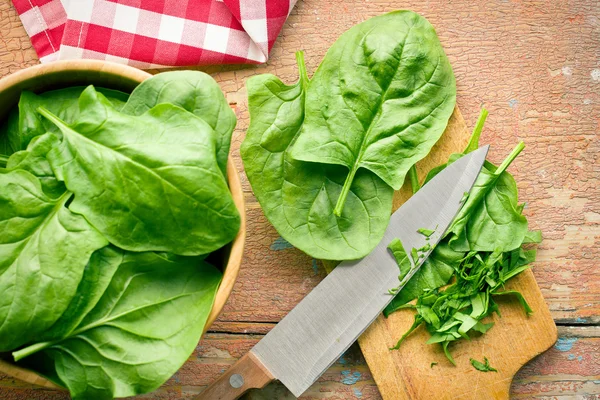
[{"x1": 6, "y1": 133, "x2": 67, "y2": 198}]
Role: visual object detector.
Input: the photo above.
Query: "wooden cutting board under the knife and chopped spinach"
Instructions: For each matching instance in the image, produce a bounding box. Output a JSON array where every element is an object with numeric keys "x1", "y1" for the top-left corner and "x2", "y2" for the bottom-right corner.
[{"x1": 324, "y1": 108, "x2": 557, "y2": 400}]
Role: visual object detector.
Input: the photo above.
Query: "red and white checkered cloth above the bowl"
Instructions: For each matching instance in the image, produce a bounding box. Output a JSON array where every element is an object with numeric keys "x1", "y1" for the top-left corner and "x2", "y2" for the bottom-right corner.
[{"x1": 12, "y1": 0, "x2": 296, "y2": 69}]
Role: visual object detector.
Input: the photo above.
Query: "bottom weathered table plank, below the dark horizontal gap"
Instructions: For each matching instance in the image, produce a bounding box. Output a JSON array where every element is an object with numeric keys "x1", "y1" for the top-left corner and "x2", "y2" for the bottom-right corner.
[{"x1": 0, "y1": 325, "x2": 600, "y2": 400}]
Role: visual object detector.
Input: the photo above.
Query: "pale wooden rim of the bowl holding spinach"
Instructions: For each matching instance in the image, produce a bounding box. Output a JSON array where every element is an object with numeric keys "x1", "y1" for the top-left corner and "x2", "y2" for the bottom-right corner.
[{"x1": 0, "y1": 60, "x2": 246, "y2": 390}]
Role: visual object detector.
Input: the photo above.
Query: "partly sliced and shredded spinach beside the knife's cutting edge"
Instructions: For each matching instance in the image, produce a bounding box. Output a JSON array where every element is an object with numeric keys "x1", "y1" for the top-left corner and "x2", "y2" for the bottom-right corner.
[{"x1": 384, "y1": 110, "x2": 542, "y2": 371}]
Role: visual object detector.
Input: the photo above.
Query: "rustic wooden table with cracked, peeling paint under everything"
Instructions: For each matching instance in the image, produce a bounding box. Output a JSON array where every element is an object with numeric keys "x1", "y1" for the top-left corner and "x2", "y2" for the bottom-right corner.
[{"x1": 0, "y1": 0, "x2": 600, "y2": 400}]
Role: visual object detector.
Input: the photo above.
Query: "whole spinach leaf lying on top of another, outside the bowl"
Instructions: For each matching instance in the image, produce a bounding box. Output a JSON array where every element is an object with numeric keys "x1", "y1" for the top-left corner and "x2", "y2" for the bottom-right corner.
[{"x1": 291, "y1": 11, "x2": 456, "y2": 216}]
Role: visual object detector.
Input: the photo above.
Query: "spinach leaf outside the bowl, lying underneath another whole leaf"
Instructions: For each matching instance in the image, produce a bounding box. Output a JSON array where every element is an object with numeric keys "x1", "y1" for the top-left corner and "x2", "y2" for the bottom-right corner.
[{"x1": 241, "y1": 53, "x2": 393, "y2": 260}]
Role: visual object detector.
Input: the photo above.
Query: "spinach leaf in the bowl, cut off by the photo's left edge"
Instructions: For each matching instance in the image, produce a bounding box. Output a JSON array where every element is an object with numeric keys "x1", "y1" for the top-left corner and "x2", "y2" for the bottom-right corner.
[{"x1": 0, "y1": 170, "x2": 108, "y2": 351}]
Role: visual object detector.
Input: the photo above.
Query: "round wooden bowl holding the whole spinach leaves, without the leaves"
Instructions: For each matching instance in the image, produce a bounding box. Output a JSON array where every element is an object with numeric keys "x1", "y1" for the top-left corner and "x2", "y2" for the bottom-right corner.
[{"x1": 0, "y1": 60, "x2": 246, "y2": 389}]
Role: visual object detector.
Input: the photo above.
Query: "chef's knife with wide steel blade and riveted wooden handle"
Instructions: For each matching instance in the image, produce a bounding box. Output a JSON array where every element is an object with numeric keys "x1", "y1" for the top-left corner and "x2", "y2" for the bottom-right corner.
[{"x1": 195, "y1": 146, "x2": 489, "y2": 400}]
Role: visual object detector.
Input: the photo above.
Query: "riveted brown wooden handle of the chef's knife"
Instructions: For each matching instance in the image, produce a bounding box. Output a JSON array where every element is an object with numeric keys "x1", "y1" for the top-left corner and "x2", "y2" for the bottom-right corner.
[{"x1": 193, "y1": 352, "x2": 275, "y2": 400}]
